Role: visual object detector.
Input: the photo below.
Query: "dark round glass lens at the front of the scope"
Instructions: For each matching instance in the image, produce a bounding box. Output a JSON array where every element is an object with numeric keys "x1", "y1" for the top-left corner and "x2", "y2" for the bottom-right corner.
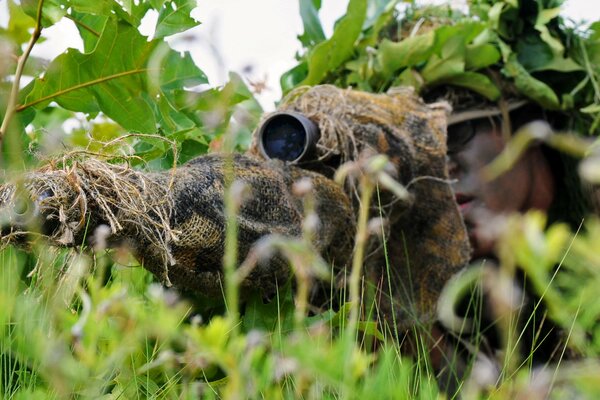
[{"x1": 262, "y1": 115, "x2": 306, "y2": 161}]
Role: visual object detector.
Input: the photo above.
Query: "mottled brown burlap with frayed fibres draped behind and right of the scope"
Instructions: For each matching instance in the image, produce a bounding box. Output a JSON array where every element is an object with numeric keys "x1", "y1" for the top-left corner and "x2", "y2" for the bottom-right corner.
[{"x1": 251, "y1": 86, "x2": 470, "y2": 328}]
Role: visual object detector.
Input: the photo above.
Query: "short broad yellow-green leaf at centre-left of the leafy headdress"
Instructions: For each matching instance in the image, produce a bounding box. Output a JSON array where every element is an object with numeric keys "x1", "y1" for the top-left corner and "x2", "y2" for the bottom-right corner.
[{"x1": 377, "y1": 32, "x2": 434, "y2": 75}]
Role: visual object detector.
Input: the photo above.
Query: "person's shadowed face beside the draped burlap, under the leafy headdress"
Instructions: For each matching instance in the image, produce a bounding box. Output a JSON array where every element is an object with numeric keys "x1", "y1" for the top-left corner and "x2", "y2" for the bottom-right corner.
[{"x1": 448, "y1": 118, "x2": 551, "y2": 258}]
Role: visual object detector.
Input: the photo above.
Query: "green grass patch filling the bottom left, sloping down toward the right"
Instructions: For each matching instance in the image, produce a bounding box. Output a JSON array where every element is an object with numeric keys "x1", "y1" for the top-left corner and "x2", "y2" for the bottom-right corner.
[{"x1": 0, "y1": 247, "x2": 437, "y2": 398}]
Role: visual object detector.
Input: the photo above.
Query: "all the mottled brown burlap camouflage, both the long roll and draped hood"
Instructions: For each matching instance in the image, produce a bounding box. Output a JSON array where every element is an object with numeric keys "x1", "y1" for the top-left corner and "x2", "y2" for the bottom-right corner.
[{"x1": 2, "y1": 86, "x2": 469, "y2": 330}]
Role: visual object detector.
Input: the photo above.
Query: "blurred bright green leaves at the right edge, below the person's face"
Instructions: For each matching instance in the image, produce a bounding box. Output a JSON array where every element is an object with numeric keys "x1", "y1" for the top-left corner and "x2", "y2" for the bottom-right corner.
[{"x1": 504, "y1": 213, "x2": 600, "y2": 357}]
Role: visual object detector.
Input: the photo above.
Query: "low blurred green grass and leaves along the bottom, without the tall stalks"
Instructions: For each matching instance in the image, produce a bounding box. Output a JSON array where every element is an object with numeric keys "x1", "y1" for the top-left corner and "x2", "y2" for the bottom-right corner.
[{"x1": 0, "y1": 213, "x2": 600, "y2": 399}]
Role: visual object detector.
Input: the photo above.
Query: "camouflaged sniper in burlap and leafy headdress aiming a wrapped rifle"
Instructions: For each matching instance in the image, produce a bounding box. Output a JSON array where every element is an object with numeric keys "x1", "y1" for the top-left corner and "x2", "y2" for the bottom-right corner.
[{"x1": 0, "y1": 2, "x2": 599, "y2": 396}]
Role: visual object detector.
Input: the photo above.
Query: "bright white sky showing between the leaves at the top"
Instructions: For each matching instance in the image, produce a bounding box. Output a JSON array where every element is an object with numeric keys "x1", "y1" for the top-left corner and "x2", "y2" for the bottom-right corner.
[{"x1": 0, "y1": 0, "x2": 600, "y2": 110}]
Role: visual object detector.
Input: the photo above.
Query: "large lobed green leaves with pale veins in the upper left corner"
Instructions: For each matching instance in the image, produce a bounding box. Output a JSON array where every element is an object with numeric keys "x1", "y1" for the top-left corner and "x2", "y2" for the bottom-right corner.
[{"x1": 0, "y1": 0, "x2": 262, "y2": 168}]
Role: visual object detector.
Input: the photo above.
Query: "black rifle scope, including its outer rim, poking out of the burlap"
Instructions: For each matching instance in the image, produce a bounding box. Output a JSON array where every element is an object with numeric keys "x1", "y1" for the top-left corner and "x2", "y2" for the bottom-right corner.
[{"x1": 258, "y1": 111, "x2": 320, "y2": 162}]
